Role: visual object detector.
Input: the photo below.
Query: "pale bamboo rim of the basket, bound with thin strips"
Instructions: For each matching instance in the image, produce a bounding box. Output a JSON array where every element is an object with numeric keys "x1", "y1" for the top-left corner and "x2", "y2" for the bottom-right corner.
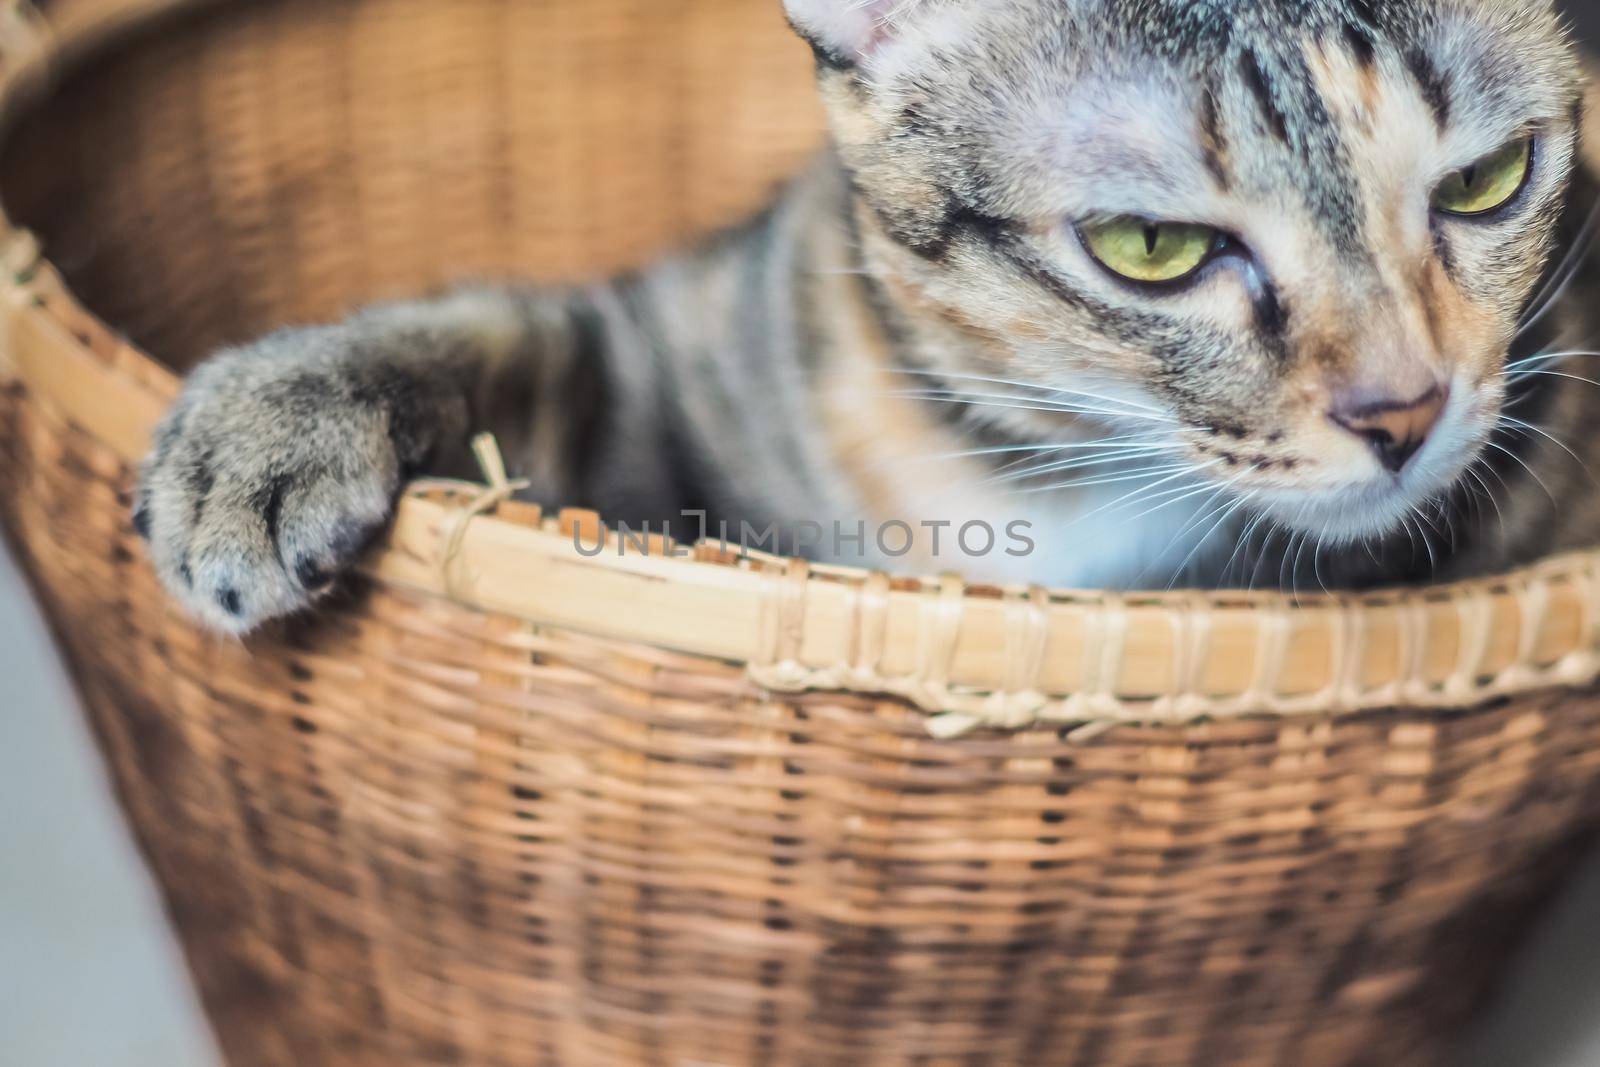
[{"x1": 0, "y1": 0, "x2": 1600, "y2": 736}]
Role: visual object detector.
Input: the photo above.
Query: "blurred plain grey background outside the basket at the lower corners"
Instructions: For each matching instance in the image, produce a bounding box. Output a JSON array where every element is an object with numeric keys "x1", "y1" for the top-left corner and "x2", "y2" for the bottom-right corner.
[{"x1": 0, "y1": 0, "x2": 1600, "y2": 1067}]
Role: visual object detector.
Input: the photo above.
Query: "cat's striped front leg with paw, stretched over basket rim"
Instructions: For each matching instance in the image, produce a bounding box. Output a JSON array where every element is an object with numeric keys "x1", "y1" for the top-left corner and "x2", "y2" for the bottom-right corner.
[{"x1": 134, "y1": 287, "x2": 576, "y2": 633}]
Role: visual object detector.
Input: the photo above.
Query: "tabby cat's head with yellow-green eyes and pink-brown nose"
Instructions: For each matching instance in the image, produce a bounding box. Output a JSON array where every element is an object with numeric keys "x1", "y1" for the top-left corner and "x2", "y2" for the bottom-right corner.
[{"x1": 787, "y1": 0, "x2": 1581, "y2": 539}]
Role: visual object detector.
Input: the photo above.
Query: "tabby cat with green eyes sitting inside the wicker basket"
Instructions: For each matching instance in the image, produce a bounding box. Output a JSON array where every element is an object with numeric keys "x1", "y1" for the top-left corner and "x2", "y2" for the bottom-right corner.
[{"x1": 134, "y1": 0, "x2": 1600, "y2": 633}]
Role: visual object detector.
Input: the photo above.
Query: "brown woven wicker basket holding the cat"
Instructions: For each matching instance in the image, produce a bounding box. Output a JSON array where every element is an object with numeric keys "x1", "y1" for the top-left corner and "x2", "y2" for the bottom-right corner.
[{"x1": 0, "y1": 0, "x2": 1600, "y2": 1067}]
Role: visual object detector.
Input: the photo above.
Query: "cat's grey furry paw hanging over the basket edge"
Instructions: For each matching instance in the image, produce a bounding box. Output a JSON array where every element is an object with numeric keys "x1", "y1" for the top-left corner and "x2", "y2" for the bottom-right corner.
[{"x1": 134, "y1": 331, "x2": 402, "y2": 633}]
